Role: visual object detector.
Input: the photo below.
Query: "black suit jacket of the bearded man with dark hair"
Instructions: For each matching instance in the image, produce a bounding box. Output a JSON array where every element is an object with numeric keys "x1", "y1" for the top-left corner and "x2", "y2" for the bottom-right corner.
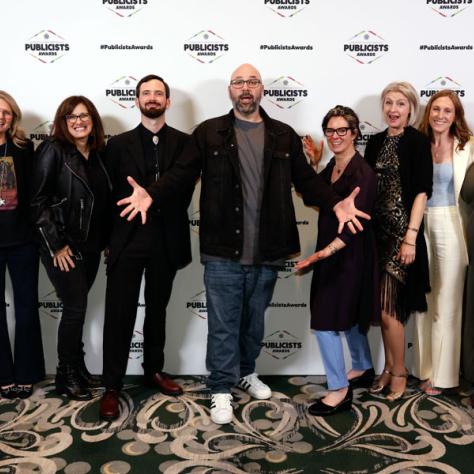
[{"x1": 105, "y1": 122, "x2": 194, "y2": 269}]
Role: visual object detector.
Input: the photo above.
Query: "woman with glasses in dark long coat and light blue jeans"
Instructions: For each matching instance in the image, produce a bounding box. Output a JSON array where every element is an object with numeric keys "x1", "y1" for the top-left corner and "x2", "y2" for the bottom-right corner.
[{"x1": 296, "y1": 105, "x2": 380, "y2": 416}]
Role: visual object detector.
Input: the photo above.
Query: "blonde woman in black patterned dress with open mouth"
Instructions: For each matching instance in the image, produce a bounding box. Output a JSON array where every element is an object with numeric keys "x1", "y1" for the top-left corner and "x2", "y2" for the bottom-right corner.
[{"x1": 365, "y1": 82, "x2": 433, "y2": 401}]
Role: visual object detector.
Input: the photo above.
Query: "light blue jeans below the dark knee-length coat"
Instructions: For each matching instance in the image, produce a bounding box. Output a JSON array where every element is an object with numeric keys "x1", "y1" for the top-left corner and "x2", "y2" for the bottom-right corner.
[{"x1": 316, "y1": 326, "x2": 372, "y2": 390}]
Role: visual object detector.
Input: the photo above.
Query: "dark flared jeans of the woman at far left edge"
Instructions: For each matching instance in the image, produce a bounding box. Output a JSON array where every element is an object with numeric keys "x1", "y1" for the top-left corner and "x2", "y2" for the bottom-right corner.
[{"x1": 0, "y1": 243, "x2": 44, "y2": 385}]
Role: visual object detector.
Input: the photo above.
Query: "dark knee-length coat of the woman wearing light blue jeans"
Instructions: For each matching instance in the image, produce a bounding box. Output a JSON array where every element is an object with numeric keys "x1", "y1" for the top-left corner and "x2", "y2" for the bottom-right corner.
[{"x1": 311, "y1": 153, "x2": 380, "y2": 333}]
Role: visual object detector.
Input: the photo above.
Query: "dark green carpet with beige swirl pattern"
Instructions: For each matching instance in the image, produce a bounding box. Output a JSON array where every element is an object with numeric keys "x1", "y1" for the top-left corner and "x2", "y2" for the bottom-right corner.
[{"x1": 0, "y1": 376, "x2": 474, "y2": 474}]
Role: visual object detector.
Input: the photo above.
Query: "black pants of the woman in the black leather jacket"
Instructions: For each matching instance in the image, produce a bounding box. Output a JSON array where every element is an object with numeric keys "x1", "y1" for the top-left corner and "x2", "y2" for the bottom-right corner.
[{"x1": 41, "y1": 250, "x2": 100, "y2": 366}]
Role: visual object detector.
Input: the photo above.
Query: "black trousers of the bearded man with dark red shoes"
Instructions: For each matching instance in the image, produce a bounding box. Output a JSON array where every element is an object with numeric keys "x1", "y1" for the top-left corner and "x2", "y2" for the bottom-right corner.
[{"x1": 103, "y1": 221, "x2": 177, "y2": 390}]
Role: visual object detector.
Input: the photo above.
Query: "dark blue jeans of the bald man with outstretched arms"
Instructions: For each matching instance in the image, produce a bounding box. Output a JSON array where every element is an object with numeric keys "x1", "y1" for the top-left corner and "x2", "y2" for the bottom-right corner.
[{"x1": 204, "y1": 261, "x2": 277, "y2": 393}]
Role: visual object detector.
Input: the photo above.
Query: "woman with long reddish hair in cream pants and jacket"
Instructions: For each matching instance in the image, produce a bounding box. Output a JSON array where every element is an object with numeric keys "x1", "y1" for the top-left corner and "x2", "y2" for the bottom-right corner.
[{"x1": 413, "y1": 90, "x2": 474, "y2": 395}]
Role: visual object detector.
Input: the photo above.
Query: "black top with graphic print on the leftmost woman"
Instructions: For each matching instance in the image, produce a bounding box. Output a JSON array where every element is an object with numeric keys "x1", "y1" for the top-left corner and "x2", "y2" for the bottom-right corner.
[{"x1": 0, "y1": 140, "x2": 34, "y2": 247}]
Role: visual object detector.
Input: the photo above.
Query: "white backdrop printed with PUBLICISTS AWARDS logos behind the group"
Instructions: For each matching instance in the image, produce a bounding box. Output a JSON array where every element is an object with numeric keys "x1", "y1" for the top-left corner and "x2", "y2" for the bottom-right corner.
[{"x1": 0, "y1": 0, "x2": 474, "y2": 374}]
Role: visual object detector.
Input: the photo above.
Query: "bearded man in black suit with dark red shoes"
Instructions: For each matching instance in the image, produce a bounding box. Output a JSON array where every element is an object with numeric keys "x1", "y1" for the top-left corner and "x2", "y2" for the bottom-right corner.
[{"x1": 100, "y1": 75, "x2": 194, "y2": 420}]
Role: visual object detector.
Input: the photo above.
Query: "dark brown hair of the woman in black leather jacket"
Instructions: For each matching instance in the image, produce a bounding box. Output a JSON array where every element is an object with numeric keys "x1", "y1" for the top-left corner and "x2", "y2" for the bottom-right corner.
[{"x1": 51, "y1": 95, "x2": 105, "y2": 150}]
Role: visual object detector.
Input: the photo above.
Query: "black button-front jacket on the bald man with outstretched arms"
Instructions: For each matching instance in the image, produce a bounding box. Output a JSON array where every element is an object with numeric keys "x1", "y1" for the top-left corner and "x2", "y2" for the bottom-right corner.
[{"x1": 147, "y1": 109, "x2": 340, "y2": 261}]
